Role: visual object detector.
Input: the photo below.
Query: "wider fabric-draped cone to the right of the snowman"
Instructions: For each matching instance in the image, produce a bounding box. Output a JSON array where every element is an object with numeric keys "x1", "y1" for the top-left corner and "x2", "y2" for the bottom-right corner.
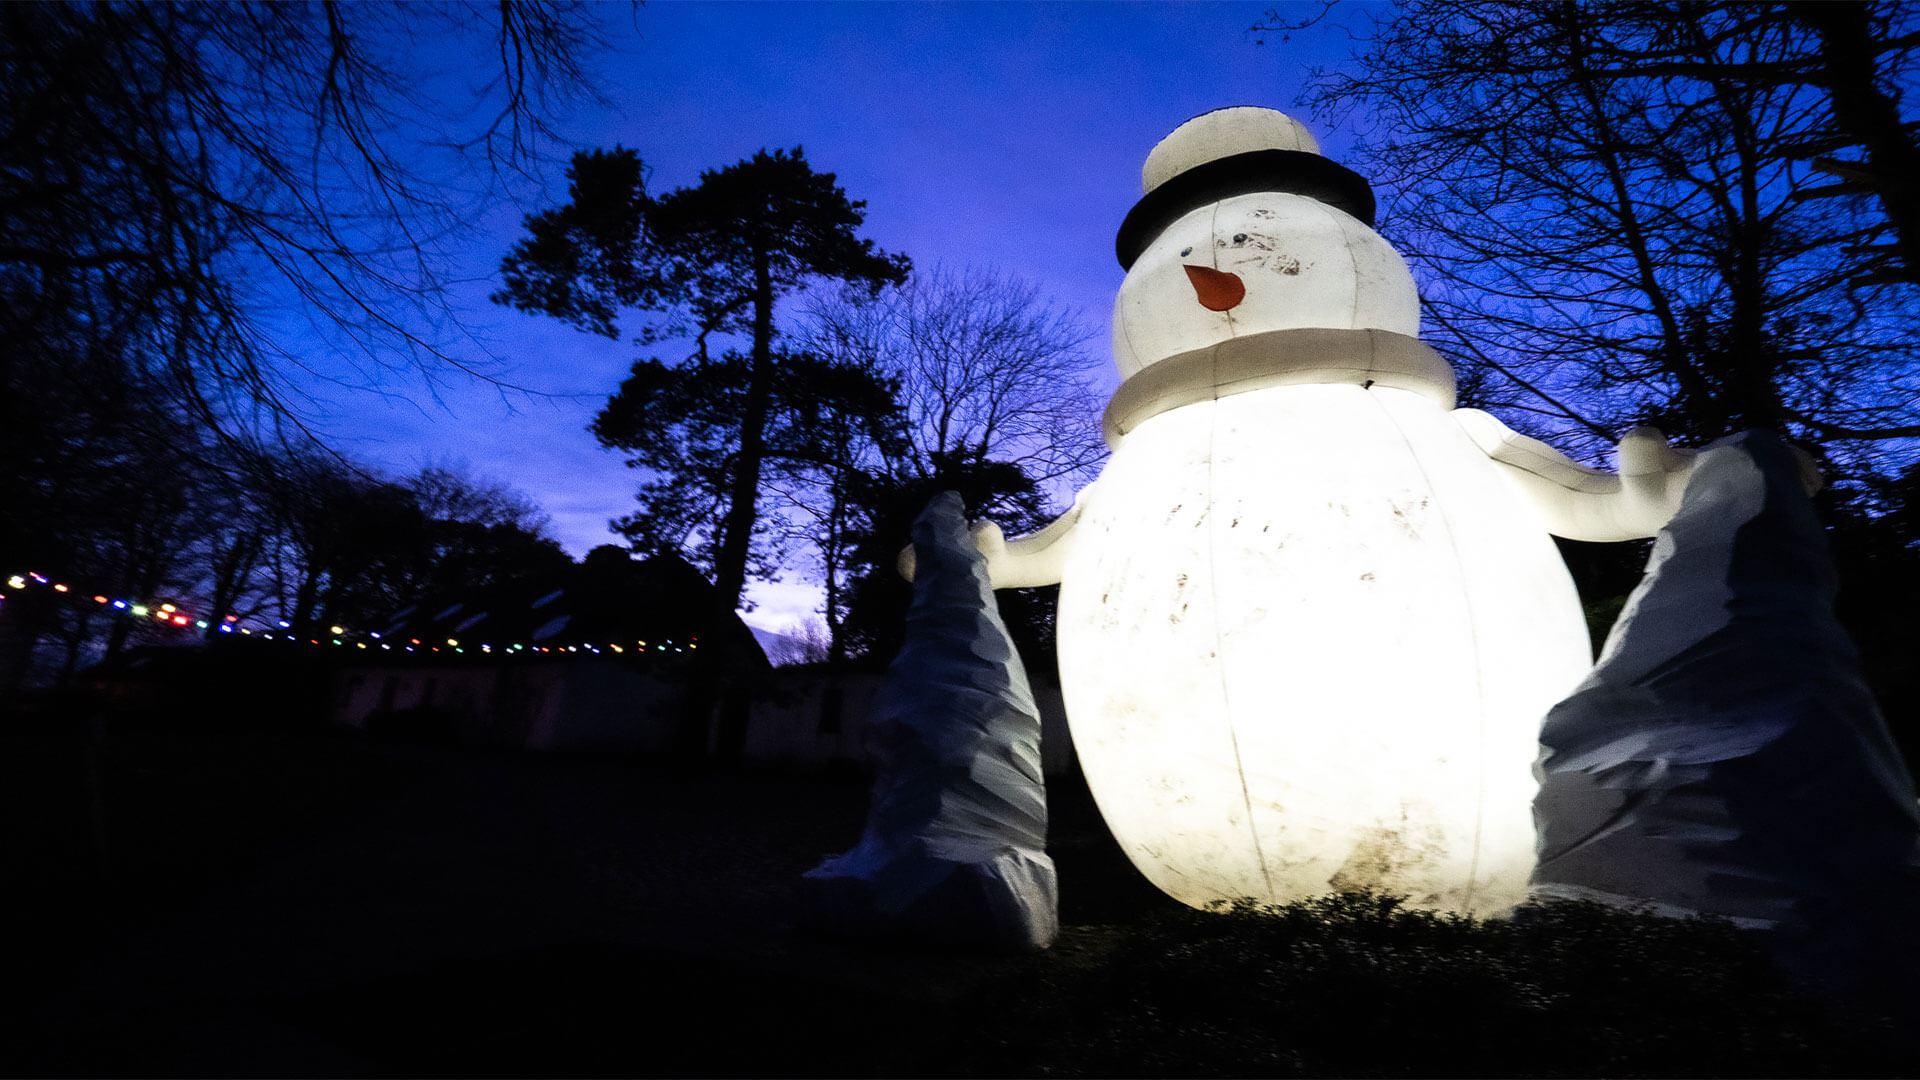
[{"x1": 1534, "y1": 432, "x2": 1920, "y2": 991}]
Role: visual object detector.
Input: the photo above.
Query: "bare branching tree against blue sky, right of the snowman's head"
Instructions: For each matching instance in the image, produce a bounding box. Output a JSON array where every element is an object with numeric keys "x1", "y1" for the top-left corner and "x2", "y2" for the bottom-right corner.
[{"x1": 1315, "y1": 0, "x2": 1920, "y2": 471}]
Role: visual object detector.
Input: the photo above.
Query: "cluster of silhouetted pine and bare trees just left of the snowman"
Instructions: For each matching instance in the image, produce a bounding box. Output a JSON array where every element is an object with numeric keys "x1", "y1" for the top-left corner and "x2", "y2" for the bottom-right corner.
[{"x1": 495, "y1": 148, "x2": 1102, "y2": 663}]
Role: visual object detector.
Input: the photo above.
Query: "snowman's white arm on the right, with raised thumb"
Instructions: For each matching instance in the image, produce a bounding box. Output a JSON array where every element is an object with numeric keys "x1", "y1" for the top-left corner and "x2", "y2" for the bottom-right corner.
[{"x1": 1453, "y1": 409, "x2": 1695, "y2": 542}]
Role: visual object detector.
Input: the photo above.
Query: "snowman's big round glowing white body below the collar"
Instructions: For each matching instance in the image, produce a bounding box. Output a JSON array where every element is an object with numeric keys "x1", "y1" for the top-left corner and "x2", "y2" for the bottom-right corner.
[{"x1": 1060, "y1": 382, "x2": 1590, "y2": 911}]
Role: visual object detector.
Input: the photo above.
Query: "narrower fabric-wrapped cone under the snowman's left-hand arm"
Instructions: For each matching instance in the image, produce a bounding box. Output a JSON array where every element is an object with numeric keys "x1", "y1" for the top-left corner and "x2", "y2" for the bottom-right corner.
[{"x1": 806, "y1": 492, "x2": 1060, "y2": 949}]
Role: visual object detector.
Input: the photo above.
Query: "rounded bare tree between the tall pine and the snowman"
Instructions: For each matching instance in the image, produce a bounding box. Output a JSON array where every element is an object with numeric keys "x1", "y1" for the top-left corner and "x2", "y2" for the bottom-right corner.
[{"x1": 806, "y1": 269, "x2": 1106, "y2": 661}]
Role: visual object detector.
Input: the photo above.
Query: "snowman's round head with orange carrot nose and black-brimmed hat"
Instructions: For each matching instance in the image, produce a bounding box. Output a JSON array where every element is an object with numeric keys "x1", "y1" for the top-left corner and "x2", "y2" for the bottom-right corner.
[{"x1": 1114, "y1": 108, "x2": 1419, "y2": 379}]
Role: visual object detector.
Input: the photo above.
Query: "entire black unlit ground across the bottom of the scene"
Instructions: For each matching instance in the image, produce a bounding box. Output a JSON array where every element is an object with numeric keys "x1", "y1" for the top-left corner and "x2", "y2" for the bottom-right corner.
[{"x1": 0, "y1": 701, "x2": 1920, "y2": 1076}]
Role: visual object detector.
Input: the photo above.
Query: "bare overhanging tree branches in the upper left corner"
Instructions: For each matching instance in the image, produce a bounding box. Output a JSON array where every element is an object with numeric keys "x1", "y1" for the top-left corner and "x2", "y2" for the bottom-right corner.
[{"x1": 0, "y1": 0, "x2": 599, "y2": 427}]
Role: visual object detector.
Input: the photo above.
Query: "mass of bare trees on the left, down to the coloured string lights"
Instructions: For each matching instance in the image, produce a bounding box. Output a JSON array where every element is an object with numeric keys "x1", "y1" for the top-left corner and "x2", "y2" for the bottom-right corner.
[{"x1": 0, "y1": 0, "x2": 599, "y2": 688}]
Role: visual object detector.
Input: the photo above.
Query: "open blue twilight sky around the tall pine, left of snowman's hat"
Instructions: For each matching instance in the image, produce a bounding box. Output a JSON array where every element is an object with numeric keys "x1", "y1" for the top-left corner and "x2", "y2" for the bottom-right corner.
[{"x1": 295, "y1": 0, "x2": 1375, "y2": 628}]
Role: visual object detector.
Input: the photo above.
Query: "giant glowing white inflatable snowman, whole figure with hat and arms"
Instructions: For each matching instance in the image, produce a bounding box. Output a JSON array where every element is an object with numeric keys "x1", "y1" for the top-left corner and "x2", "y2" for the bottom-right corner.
[{"x1": 944, "y1": 108, "x2": 1690, "y2": 911}]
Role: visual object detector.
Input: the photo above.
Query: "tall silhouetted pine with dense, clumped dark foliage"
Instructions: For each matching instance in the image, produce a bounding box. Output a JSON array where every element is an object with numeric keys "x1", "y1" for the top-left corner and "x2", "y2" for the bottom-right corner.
[{"x1": 493, "y1": 148, "x2": 908, "y2": 603}]
